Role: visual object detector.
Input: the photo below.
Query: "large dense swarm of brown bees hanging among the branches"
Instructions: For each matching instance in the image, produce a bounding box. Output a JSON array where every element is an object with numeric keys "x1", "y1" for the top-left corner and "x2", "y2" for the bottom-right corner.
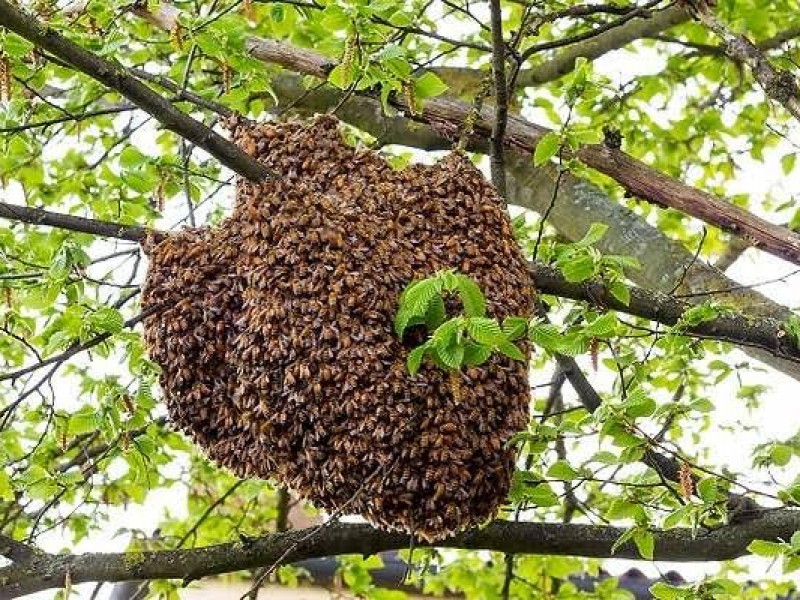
[{"x1": 143, "y1": 117, "x2": 534, "y2": 540}]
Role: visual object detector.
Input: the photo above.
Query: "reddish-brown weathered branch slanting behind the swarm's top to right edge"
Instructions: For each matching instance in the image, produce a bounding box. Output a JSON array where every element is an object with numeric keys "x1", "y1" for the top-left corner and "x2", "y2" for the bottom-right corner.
[{"x1": 246, "y1": 38, "x2": 800, "y2": 265}]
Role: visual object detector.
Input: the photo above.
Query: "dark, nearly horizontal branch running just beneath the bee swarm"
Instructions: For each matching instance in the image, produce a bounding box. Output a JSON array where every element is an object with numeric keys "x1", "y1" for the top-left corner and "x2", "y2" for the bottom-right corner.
[{"x1": 0, "y1": 509, "x2": 800, "y2": 597}]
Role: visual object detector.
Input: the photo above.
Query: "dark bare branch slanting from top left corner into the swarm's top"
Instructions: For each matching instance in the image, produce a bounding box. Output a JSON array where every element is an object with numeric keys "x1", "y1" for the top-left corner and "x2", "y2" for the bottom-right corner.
[{"x1": 0, "y1": 0, "x2": 270, "y2": 181}]
